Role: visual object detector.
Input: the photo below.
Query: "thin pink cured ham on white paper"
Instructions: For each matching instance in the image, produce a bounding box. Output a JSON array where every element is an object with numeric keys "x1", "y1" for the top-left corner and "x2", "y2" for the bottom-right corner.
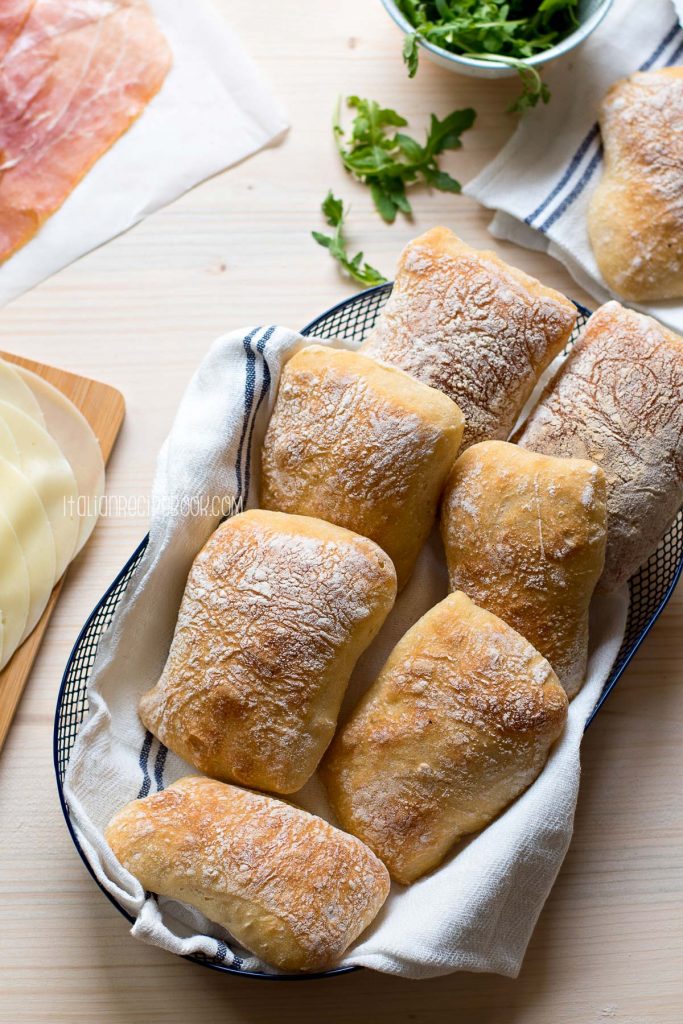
[{"x1": 0, "y1": 0, "x2": 171, "y2": 261}]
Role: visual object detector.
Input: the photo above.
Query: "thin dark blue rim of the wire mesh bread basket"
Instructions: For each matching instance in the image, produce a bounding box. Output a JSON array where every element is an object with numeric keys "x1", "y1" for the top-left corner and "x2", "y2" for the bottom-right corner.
[{"x1": 52, "y1": 282, "x2": 683, "y2": 981}]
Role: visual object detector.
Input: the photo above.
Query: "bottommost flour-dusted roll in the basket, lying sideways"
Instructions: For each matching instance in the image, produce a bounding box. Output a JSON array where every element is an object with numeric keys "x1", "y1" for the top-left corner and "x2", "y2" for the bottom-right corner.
[{"x1": 105, "y1": 776, "x2": 389, "y2": 971}]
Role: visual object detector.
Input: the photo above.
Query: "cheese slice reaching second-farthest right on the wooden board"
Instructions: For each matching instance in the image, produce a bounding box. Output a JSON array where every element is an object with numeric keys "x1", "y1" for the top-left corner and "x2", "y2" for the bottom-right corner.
[{"x1": 0, "y1": 401, "x2": 80, "y2": 580}]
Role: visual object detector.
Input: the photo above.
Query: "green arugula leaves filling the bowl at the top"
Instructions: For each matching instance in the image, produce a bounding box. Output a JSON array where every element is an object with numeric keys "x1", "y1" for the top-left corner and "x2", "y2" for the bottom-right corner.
[{"x1": 397, "y1": 0, "x2": 579, "y2": 111}]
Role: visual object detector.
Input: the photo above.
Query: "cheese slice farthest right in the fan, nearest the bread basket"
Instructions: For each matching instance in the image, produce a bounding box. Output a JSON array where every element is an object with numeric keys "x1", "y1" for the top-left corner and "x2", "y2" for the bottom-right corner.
[{"x1": 16, "y1": 367, "x2": 104, "y2": 557}]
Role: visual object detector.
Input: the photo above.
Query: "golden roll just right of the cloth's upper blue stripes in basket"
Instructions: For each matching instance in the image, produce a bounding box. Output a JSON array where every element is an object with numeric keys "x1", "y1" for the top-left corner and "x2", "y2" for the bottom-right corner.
[{"x1": 261, "y1": 345, "x2": 463, "y2": 590}]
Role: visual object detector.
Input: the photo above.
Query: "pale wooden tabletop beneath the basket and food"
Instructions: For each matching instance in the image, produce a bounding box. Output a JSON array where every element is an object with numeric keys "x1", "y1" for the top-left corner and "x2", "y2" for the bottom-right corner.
[{"x1": 0, "y1": 0, "x2": 683, "y2": 1024}]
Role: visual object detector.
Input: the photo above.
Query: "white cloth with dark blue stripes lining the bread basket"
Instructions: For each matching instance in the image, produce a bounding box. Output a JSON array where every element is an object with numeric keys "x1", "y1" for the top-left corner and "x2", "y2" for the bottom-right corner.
[{"x1": 65, "y1": 327, "x2": 628, "y2": 978}]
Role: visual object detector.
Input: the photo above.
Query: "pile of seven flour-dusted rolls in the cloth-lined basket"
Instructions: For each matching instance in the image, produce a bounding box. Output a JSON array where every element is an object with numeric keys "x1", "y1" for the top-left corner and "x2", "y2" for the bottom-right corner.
[{"x1": 108, "y1": 228, "x2": 683, "y2": 971}]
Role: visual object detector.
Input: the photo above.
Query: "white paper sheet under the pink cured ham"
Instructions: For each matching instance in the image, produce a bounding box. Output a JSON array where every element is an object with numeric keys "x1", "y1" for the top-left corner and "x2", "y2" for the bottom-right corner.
[{"x1": 0, "y1": 0, "x2": 287, "y2": 305}]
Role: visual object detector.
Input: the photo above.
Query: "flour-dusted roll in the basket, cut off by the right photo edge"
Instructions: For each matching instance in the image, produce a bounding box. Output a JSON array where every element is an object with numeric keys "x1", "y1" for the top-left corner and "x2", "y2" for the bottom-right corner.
[{"x1": 518, "y1": 302, "x2": 683, "y2": 590}]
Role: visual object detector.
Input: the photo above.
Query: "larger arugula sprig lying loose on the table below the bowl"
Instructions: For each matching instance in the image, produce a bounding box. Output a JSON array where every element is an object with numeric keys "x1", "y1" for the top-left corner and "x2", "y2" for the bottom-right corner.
[{"x1": 334, "y1": 96, "x2": 476, "y2": 224}]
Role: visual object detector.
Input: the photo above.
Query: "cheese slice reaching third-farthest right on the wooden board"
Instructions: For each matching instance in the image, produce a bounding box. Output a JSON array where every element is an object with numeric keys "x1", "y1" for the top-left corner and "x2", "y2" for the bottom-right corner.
[{"x1": 0, "y1": 459, "x2": 56, "y2": 640}]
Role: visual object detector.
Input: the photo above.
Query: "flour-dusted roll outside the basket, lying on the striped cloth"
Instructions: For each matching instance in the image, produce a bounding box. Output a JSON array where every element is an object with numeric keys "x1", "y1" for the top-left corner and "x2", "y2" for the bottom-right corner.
[{"x1": 588, "y1": 68, "x2": 683, "y2": 302}]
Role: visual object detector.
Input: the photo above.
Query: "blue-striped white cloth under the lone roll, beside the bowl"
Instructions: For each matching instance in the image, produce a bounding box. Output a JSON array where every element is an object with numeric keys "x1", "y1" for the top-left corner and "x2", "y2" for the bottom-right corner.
[{"x1": 464, "y1": 0, "x2": 683, "y2": 332}]
